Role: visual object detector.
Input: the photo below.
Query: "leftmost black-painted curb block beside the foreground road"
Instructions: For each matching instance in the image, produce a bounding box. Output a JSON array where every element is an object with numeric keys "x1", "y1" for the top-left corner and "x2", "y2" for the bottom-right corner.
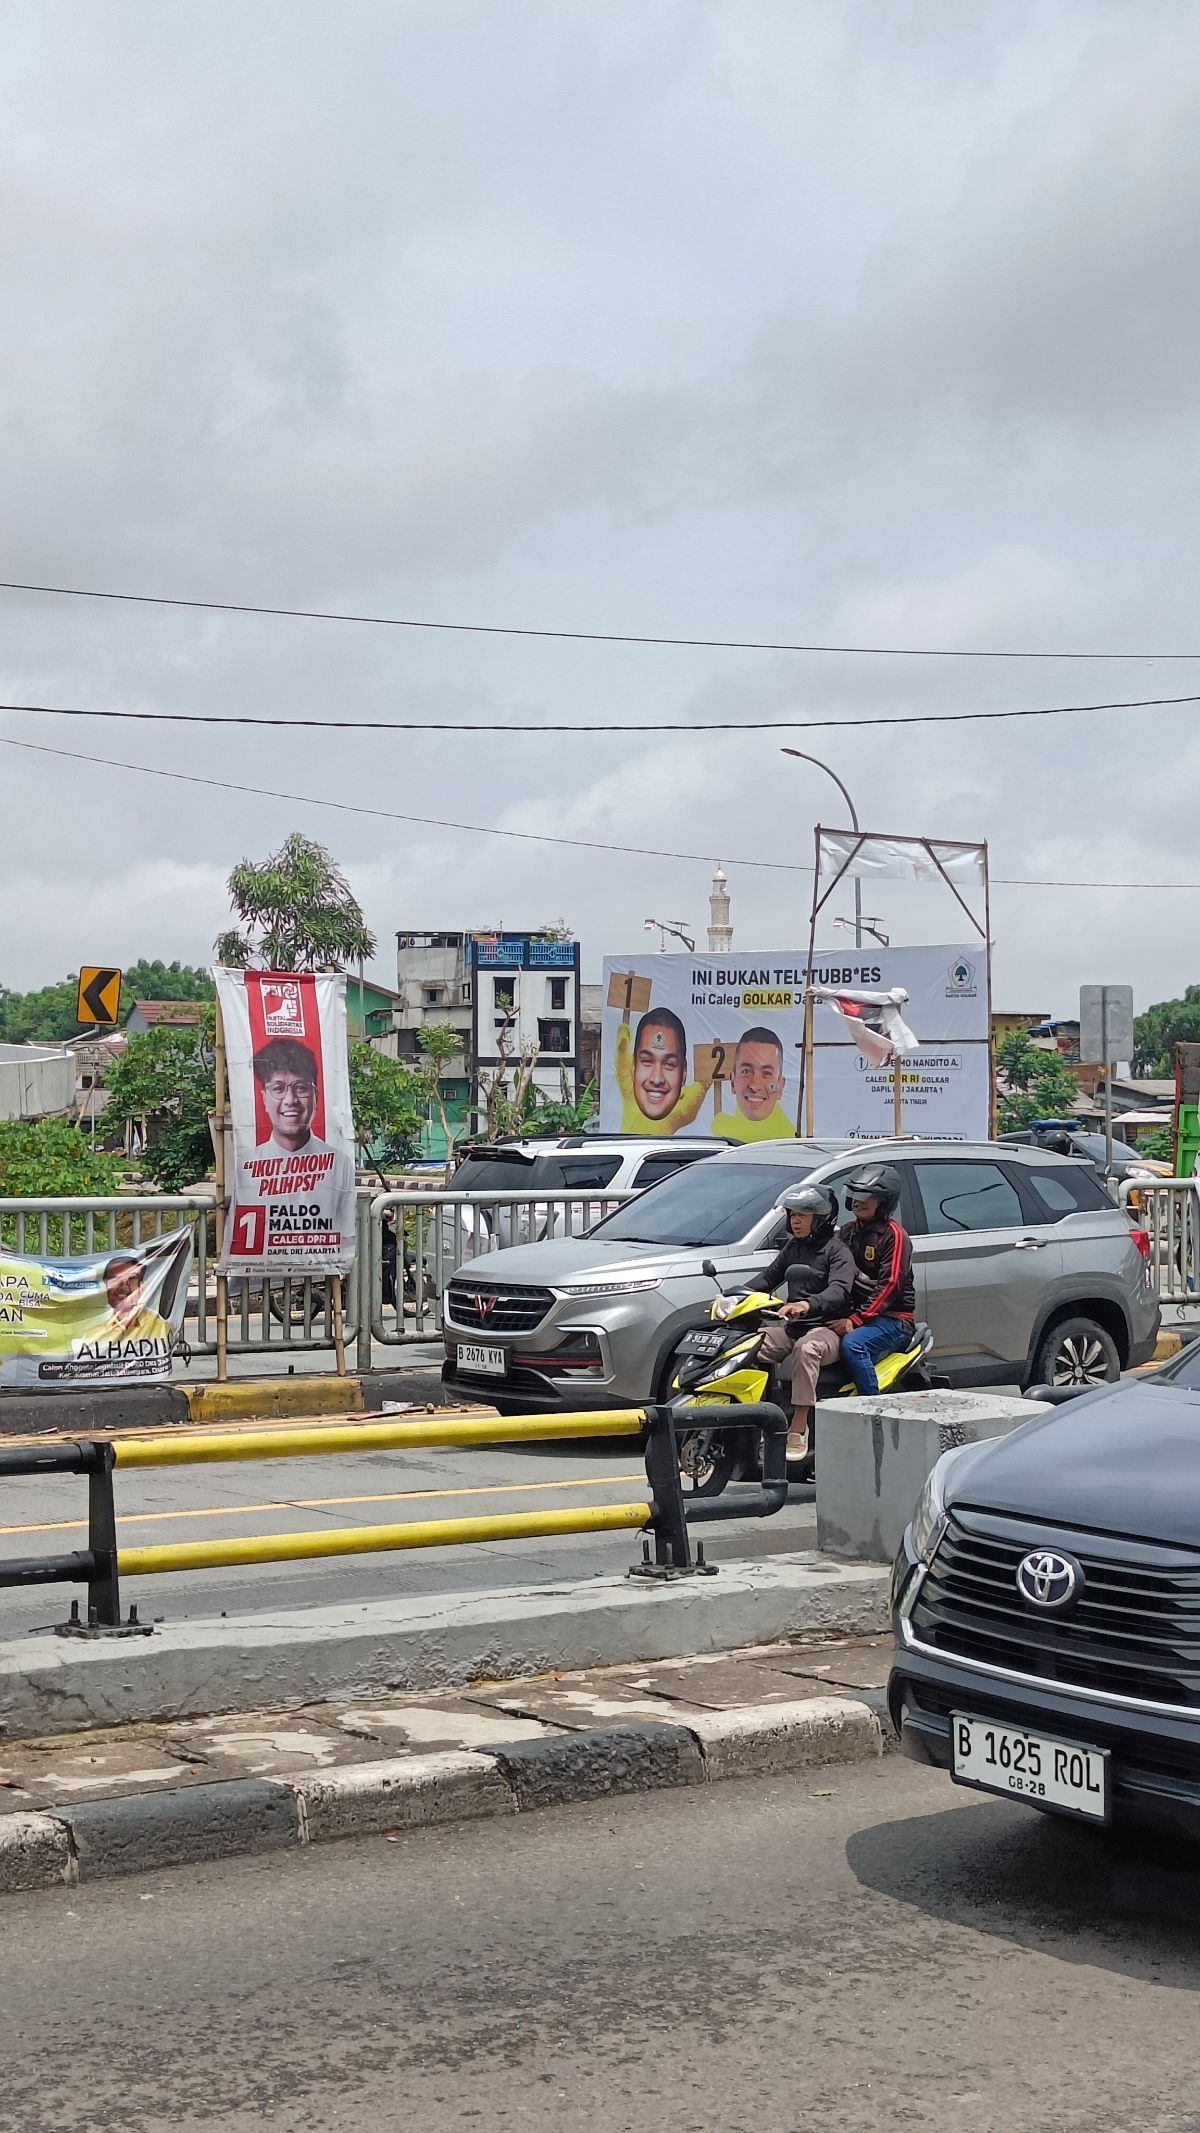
[{"x1": 55, "y1": 1777, "x2": 301, "y2": 1881}]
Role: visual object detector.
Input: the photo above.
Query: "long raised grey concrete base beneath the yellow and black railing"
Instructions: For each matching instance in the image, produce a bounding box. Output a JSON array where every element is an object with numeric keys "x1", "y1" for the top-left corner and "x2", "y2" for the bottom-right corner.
[{"x1": 0, "y1": 1555, "x2": 887, "y2": 1747}]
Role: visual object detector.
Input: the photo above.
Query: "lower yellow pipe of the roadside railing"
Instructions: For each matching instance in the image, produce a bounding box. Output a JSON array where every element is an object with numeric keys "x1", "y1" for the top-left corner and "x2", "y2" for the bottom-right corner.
[{"x1": 117, "y1": 1504, "x2": 652, "y2": 1578}]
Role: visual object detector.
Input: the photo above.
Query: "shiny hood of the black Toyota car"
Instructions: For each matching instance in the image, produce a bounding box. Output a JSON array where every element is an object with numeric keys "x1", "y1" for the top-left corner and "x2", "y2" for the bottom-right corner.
[{"x1": 946, "y1": 1382, "x2": 1200, "y2": 1549}]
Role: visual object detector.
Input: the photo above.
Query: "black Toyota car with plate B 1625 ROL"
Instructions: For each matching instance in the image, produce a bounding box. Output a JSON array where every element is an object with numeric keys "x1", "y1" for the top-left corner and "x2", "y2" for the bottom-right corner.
[{"x1": 889, "y1": 1342, "x2": 1200, "y2": 1826}]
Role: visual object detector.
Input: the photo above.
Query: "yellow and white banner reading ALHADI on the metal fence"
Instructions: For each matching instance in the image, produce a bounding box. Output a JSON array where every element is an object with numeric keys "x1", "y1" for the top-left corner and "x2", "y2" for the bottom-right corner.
[{"x1": 0, "y1": 1229, "x2": 192, "y2": 1386}]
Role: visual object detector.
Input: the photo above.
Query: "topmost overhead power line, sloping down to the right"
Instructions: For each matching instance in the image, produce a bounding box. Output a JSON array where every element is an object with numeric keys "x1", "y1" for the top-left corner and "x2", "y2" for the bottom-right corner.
[{"x1": 0, "y1": 578, "x2": 1200, "y2": 661}]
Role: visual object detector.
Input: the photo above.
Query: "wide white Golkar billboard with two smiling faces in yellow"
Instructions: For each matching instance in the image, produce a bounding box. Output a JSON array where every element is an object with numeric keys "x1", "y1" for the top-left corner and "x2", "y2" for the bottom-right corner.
[{"x1": 599, "y1": 943, "x2": 989, "y2": 1141}]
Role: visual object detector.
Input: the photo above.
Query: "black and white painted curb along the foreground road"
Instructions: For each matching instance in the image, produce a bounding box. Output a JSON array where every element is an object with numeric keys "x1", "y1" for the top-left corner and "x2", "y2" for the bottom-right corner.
[{"x1": 0, "y1": 1696, "x2": 885, "y2": 1894}]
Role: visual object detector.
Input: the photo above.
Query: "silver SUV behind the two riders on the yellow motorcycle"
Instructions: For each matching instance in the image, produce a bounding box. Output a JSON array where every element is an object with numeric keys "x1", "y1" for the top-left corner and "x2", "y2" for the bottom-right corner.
[{"x1": 441, "y1": 1141, "x2": 1160, "y2": 1414}]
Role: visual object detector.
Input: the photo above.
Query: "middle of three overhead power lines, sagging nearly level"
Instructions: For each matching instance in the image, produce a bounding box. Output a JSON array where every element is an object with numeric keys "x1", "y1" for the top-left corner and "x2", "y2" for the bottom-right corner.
[{"x1": 0, "y1": 695, "x2": 1200, "y2": 734}]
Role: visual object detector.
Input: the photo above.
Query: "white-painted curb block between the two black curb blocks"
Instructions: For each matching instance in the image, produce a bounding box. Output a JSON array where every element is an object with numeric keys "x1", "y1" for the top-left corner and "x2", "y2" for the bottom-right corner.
[{"x1": 292, "y1": 1749, "x2": 516, "y2": 1843}]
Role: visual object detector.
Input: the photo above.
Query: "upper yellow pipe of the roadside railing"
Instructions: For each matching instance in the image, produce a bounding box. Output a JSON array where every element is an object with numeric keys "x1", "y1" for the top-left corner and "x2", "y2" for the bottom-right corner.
[{"x1": 115, "y1": 1408, "x2": 646, "y2": 1468}]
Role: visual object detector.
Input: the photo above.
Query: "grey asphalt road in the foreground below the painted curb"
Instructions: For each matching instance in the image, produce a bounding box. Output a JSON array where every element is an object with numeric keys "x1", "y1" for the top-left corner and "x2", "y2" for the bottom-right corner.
[{"x1": 0, "y1": 1758, "x2": 1200, "y2": 2133}]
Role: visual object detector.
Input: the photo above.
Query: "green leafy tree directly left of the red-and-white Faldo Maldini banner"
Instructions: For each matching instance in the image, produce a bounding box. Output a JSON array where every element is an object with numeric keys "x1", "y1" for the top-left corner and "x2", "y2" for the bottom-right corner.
[{"x1": 104, "y1": 1007, "x2": 215, "y2": 1192}]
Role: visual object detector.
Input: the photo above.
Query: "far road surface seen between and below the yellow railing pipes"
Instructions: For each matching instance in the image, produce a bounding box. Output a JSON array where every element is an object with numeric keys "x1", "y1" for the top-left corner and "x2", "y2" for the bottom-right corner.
[{"x1": 0, "y1": 1440, "x2": 816, "y2": 1638}]
